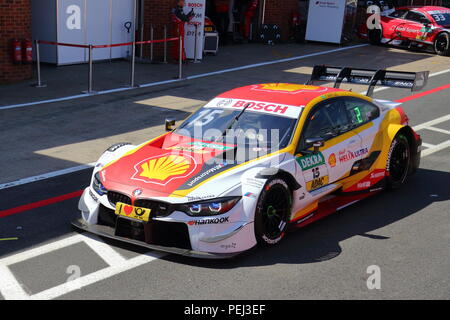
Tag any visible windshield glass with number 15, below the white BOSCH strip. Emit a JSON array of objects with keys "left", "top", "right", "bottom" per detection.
[{"left": 175, "top": 107, "right": 300, "bottom": 151}]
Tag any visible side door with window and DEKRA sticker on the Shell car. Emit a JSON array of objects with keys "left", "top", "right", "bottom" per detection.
[{"left": 296, "top": 97, "right": 362, "bottom": 194}]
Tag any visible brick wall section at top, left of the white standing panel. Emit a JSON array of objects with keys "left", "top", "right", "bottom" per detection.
[{"left": 264, "top": 0, "right": 298, "bottom": 41}]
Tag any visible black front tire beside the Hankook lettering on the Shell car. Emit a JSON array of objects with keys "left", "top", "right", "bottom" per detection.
[{"left": 255, "top": 178, "right": 292, "bottom": 246}]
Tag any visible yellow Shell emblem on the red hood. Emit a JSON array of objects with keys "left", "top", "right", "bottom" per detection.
[{"left": 139, "top": 155, "right": 190, "bottom": 181}]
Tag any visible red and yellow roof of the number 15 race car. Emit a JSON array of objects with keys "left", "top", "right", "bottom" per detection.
[{"left": 217, "top": 83, "right": 346, "bottom": 106}]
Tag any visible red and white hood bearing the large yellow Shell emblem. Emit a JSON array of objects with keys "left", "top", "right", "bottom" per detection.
[{"left": 100, "top": 133, "right": 235, "bottom": 198}]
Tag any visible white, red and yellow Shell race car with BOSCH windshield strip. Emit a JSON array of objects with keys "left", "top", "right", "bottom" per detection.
[{"left": 73, "top": 66, "right": 428, "bottom": 258}]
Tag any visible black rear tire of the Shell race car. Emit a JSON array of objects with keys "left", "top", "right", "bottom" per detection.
[{"left": 386, "top": 133, "right": 411, "bottom": 190}]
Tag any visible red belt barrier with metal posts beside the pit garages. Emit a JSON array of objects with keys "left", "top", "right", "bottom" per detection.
[{"left": 35, "top": 37, "right": 183, "bottom": 94}]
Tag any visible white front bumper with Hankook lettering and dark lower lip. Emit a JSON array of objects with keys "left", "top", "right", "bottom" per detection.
[{"left": 73, "top": 187, "right": 256, "bottom": 258}]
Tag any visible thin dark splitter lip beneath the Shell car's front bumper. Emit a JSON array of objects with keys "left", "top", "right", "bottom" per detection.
[{"left": 72, "top": 218, "right": 241, "bottom": 259}]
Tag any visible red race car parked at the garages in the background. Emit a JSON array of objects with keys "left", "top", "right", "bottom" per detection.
[{"left": 359, "top": 6, "right": 450, "bottom": 56}]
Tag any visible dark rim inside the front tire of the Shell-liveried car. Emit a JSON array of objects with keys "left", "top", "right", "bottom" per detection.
[{"left": 262, "top": 186, "right": 289, "bottom": 239}]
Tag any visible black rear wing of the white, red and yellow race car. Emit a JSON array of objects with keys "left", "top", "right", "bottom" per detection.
[{"left": 307, "top": 65, "right": 429, "bottom": 97}]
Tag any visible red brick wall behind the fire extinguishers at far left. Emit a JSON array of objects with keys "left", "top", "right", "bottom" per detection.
[{"left": 0, "top": 0, "right": 32, "bottom": 83}]
